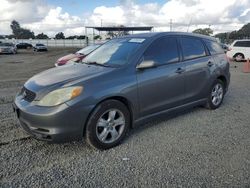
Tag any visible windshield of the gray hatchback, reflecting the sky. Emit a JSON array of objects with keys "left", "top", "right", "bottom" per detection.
[{"left": 83, "top": 38, "right": 145, "bottom": 66}]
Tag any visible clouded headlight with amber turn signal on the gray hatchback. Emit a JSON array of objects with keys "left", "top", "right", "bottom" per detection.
[{"left": 37, "top": 86, "right": 83, "bottom": 106}]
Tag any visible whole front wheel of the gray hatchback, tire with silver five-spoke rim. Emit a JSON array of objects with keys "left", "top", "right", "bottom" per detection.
[{"left": 85, "top": 100, "right": 130, "bottom": 150}]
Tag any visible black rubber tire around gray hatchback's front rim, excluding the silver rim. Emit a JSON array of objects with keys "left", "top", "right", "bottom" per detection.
[{"left": 85, "top": 100, "right": 130, "bottom": 150}]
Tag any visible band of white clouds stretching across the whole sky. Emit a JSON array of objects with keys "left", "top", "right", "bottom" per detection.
[{"left": 0, "top": 0, "right": 250, "bottom": 36}]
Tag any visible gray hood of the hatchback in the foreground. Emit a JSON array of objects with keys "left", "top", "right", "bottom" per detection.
[{"left": 24, "top": 63, "right": 113, "bottom": 92}]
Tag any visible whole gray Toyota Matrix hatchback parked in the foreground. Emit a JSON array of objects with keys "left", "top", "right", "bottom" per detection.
[{"left": 13, "top": 32, "right": 230, "bottom": 149}]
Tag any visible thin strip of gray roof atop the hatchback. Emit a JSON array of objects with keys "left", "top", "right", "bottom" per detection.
[{"left": 122, "top": 32, "right": 217, "bottom": 41}]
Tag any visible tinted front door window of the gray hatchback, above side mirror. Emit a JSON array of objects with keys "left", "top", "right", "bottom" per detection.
[{"left": 144, "top": 37, "right": 179, "bottom": 64}]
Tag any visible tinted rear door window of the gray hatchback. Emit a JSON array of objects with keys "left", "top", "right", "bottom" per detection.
[{"left": 181, "top": 37, "right": 206, "bottom": 60}]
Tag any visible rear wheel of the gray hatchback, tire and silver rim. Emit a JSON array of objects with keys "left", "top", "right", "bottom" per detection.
[{"left": 206, "top": 79, "right": 225, "bottom": 110}]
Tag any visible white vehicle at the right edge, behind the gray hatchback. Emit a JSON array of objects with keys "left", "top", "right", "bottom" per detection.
[{"left": 227, "top": 40, "right": 250, "bottom": 62}]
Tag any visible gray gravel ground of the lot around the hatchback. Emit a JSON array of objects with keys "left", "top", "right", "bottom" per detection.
[{"left": 0, "top": 49, "right": 250, "bottom": 187}]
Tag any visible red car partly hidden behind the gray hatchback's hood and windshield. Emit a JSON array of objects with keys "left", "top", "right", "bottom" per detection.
[{"left": 55, "top": 44, "right": 100, "bottom": 67}]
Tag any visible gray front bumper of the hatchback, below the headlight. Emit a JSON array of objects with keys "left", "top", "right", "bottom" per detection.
[{"left": 13, "top": 96, "right": 93, "bottom": 142}]
